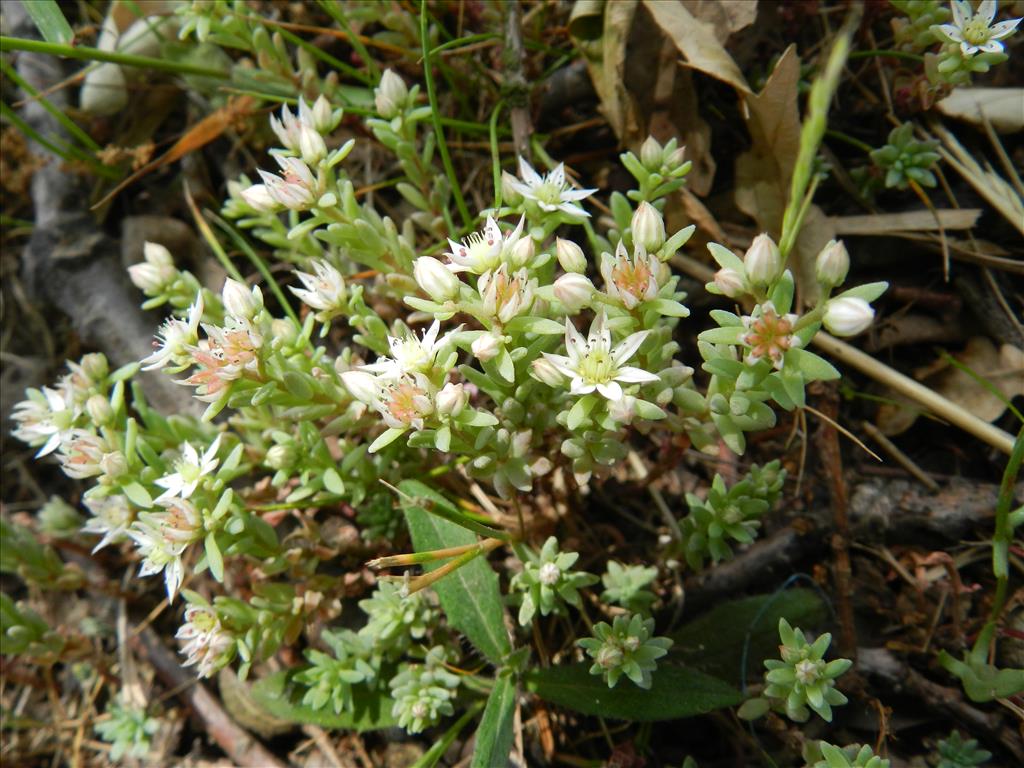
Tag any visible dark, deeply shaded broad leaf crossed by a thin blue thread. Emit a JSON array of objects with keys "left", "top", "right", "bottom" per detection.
[{"left": 655, "top": 589, "right": 825, "bottom": 684}]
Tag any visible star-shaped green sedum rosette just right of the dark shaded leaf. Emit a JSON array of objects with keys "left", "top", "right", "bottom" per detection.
[{"left": 740, "top": 618, "right": 853, "bottom": 723}]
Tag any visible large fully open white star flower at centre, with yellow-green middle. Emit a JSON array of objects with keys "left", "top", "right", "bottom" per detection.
[{"left": 544, "top": 312, "right": 658, "bottom": 400}]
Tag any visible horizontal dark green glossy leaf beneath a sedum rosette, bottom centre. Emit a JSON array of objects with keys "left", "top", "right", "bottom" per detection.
[{"left": 524, "top": 663, "right": 743, "bottom": 722}]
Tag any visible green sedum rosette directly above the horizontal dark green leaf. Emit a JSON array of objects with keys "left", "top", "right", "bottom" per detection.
[{"left": 578, "top": 613, "right": 672, "bottom": 688}]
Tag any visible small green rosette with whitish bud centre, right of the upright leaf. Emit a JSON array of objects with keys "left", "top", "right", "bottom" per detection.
[{"left": 511, "top": 537, "right": 597, "bottom": 627}]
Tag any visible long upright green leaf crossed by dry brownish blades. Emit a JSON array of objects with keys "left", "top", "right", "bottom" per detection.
[{"left": 398, "top": 480, "right": 512, "bottom": 665}]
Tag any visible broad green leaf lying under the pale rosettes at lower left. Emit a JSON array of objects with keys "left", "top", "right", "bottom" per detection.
[{"left": 250, "top": 671, "right": 398, "bottom": 733}]
